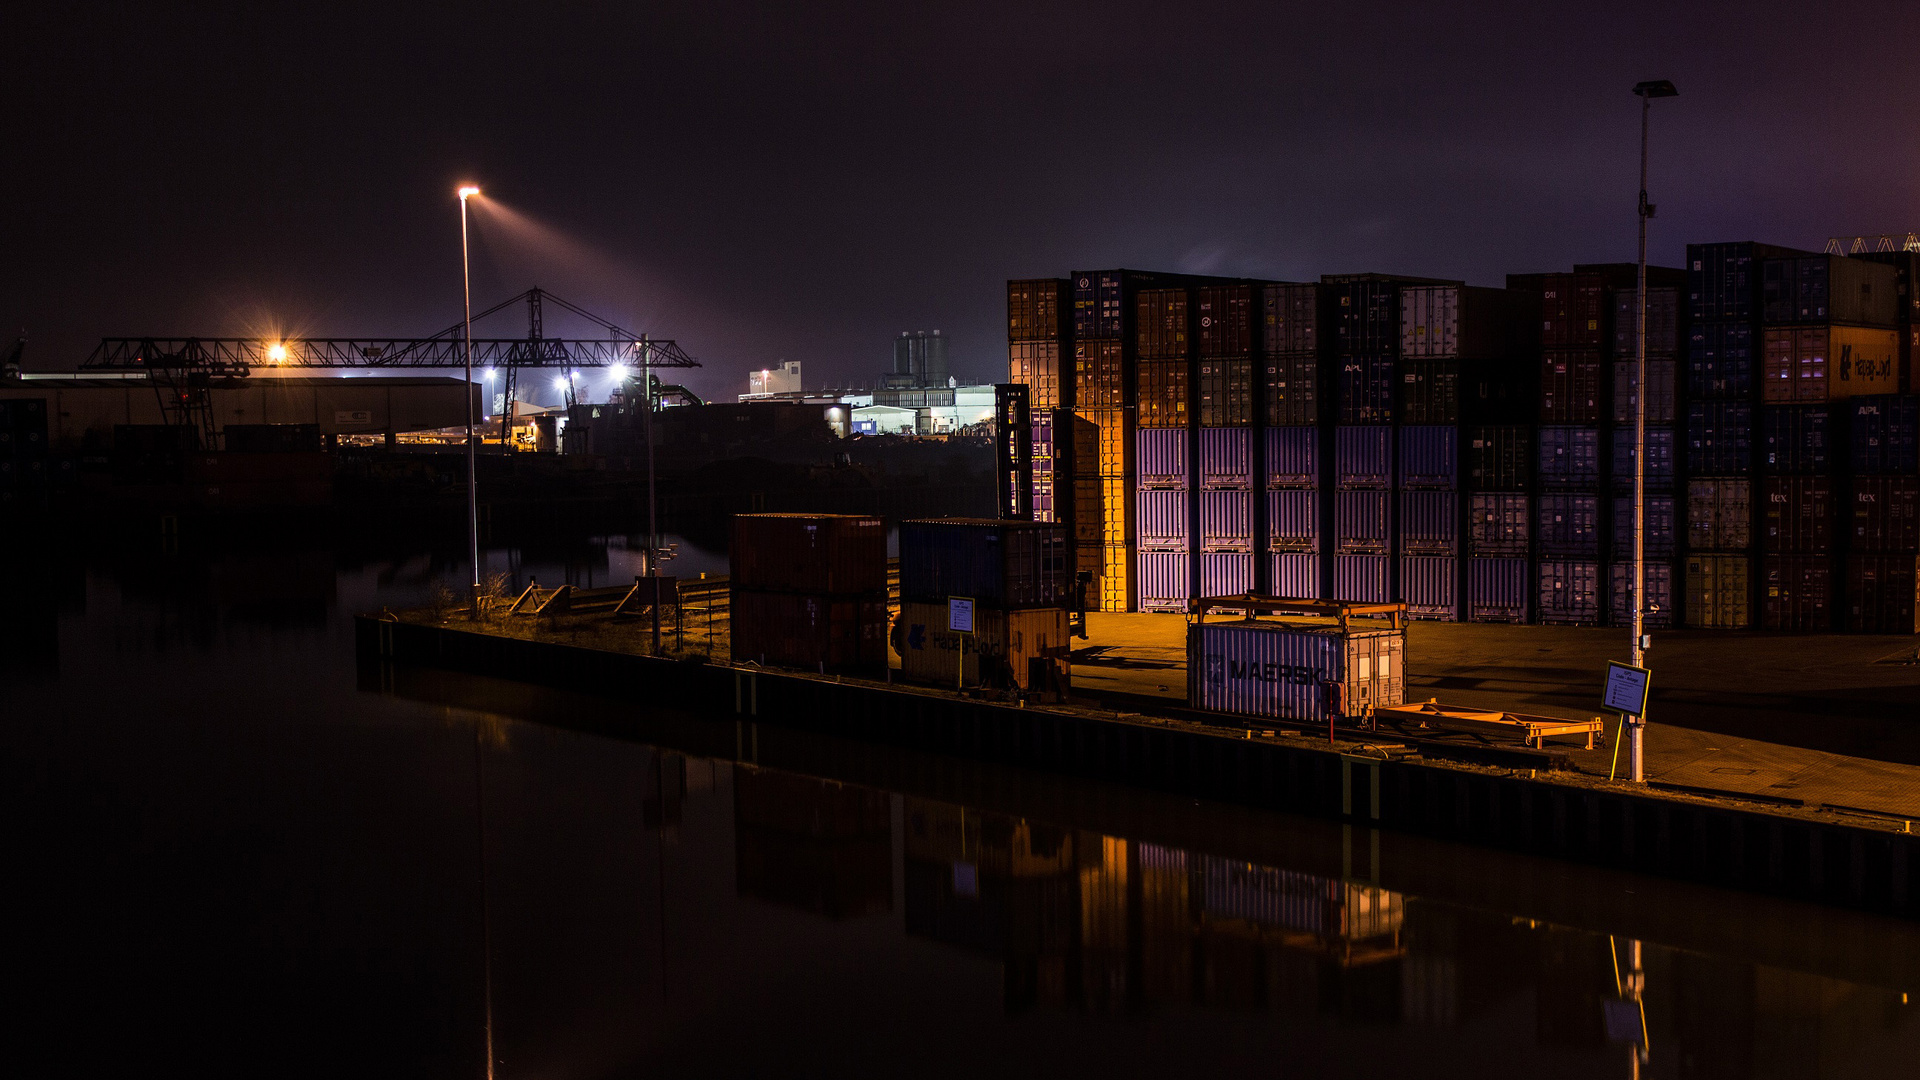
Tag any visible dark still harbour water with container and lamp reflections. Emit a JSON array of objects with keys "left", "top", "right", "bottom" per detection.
[{"left": 0, "top": 542, "right": 1920, "bottom": 1076}]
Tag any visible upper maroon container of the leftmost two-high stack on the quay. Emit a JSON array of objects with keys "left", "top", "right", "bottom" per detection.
[{"left": 732, "top": 513, "right": 887, "bottom": 600}]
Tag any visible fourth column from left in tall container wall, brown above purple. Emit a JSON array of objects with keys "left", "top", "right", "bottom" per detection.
[{"left": 1194, "top": 282, "right": 1261, "bottom": 596}]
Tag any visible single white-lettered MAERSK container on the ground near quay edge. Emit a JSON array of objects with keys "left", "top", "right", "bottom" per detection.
[{"left": 1187, "top": 619, "right": 1407, "bottom": 723}]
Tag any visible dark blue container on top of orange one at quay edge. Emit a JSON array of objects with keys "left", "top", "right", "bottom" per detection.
[{"left": 902, "top": 517, "right": 1073, "bottom": 607}]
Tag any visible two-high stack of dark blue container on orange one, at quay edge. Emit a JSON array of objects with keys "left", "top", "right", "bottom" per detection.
[{"left": 895, "top": 517, "right": 1073, "bottom": 688}]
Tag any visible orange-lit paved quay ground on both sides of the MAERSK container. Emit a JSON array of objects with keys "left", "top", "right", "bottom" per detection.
[{"left": 1073, "top": 613, "right": 1920, "bottom": 822}]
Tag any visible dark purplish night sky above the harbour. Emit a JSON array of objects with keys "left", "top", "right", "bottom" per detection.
[{"left": 0, "top": 0, "right": 1920, "bottom": 396}]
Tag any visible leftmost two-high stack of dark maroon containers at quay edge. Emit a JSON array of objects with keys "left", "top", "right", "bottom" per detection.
[{"left": 730, "top": 513, "right": 887, "bottom": 673}]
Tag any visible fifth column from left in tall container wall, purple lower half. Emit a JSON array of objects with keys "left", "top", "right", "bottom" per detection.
[{"left": 1260, "top": 282, "right": 1323, "bottom": 598}]
